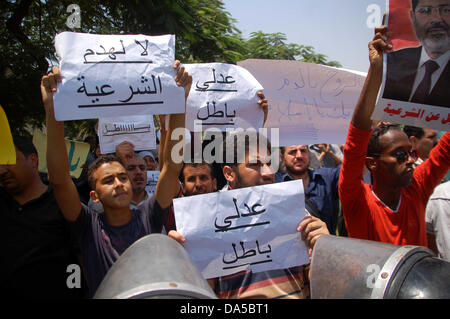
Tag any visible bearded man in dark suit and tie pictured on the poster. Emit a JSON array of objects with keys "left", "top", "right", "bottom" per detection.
[{"left": 383, "top": 0, "right": 450, "bottom": 107}]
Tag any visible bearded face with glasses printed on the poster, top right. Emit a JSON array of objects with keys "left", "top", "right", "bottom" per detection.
[{"left": 410, "top": 0, "right": 450, "bottom": 58}]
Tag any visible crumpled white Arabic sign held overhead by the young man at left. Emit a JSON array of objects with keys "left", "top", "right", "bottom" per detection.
[{"left": 55, "top": 32, "right": 184, "bottom": 121}]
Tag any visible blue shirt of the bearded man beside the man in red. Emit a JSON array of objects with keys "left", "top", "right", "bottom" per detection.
[{"left": 275, "top": 165, "right": 341, "bottom": 235}]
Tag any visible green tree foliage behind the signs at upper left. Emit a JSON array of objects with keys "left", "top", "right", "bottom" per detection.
[{"left": 0, "top": 0, "right": 338, "bottom": 137}]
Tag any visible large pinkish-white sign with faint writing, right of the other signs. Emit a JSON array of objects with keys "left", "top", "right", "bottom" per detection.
[{"left": 238, "top": 59, "right": 365, "bottom": 146}]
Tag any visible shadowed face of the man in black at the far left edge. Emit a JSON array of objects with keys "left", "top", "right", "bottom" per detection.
[{"left": 0, "top": 148, "right": 38, "bottom": 196}]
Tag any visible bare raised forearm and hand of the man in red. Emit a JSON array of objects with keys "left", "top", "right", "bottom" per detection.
[{"left": 352, "top": 26, "right": 392, "bottom": 130}]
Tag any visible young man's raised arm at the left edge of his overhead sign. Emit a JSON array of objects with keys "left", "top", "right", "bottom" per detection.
[{"left": 41, "top": 67, "right": 81, "bottom": 221}]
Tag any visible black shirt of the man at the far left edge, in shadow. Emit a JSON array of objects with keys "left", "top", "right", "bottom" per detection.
[{"left": 0, "top": 187, "right": 84, "bottom": 299}]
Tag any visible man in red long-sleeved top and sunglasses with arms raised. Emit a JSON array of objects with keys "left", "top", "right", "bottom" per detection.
[{"left": 339, "top": 26, "right": 450, "bottom": 246}]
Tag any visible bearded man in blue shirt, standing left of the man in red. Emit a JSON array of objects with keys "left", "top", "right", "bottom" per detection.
[{"left": 275, "top": 145, "right": 341, "bottom": 235}]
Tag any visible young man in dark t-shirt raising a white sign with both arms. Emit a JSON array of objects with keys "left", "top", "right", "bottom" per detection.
[{"left": 41, "top": 61, "right": 192, "bottom": 295}]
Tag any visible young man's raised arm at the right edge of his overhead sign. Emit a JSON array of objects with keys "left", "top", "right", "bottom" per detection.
[{"left": 155, "top": 60, "right": 192, "bottom": 209}]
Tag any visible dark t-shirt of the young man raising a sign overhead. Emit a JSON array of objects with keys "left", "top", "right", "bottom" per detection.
[{"left": 72, "top": 196, "right": 170, "bottom": 297}]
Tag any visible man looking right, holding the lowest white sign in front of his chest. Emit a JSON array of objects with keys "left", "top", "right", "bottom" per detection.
[{"left": 169, "top": 131, "right": 329, "bottom": 298}]
